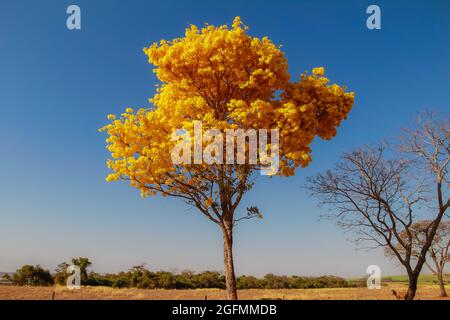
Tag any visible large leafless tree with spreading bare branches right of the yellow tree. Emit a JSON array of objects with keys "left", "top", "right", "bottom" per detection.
[{"left": 307, "top": 113, "right": 450, "bottom": 300}]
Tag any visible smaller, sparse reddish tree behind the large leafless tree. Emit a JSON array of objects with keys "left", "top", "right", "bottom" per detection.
[{"left": 385, "top": 220, "right": 450, "bottom": 297}]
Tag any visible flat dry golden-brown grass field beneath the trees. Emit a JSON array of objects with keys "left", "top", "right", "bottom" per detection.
[{"left": 0, "top": 283, "right": 450, "bottom": 300}]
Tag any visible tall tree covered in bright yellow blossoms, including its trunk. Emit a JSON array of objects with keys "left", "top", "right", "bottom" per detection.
[{"left": 100, "top": 17, "right": 354, "bottom": 299}]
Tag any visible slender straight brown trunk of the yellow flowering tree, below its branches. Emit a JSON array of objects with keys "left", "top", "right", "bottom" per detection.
[{"left": 222, "top": 222, "right": 238, "bottom": 300}]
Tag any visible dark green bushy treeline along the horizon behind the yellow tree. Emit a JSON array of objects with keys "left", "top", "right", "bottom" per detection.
[{"left": 1, "top": 258, "right": 357, "bottom": 289}]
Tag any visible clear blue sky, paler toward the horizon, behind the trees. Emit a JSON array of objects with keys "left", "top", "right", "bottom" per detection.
[{"left": 0, "top": 0, "right": 450, "bottom": 276}]
